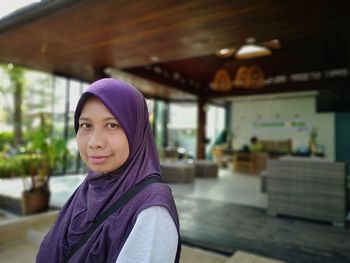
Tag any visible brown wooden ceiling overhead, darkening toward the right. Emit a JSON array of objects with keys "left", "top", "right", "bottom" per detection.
[{"left": 0, "top": 0, "right": 350, "bottom": 99}]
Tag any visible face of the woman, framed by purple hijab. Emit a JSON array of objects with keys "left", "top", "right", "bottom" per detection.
[{"left": 76, "top": 97, "right": 129, "bottom": 173}]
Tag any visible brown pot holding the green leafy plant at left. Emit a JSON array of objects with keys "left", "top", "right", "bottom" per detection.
[{"left": 22, "top": 190, "right": 50, "bottom": 215}]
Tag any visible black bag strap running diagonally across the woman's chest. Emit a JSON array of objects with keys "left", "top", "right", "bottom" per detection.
[{"left": 64, "top": 177, "right": 161, "bottom": 262}]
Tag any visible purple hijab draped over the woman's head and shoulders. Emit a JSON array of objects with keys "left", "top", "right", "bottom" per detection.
[{"left": 37, "top": 78, "right": 179, "bottom": 263}]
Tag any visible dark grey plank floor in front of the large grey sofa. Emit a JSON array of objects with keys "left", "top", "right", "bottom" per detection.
[{"left": 175, "top": 196, "right": 350, "bottom": 263}]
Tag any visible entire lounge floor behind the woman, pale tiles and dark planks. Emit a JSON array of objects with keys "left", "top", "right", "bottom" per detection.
[{"left": 0, "top": 169, "right": 350, "bottom": 263}]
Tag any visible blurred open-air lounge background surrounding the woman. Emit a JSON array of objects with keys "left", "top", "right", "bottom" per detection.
[{"left": 0, "top": 0, "right": 350, "bottom": 263}]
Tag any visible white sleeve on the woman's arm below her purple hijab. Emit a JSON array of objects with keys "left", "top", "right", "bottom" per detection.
[{"left": 116, "top": 206, "right": 179, "bottom": 263}]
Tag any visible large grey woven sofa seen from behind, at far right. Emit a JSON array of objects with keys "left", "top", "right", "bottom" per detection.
[{"left": 266, "top": 157, "right": 347, "bottom": 226}]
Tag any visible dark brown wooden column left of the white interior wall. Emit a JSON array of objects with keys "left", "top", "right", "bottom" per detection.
[{"left": 197, "top": 97, "right": 206, "bottom": 159}]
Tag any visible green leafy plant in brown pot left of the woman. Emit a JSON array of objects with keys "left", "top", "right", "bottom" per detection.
[{"left": 22, "top": 114, "right": 67, "bottom": 214}]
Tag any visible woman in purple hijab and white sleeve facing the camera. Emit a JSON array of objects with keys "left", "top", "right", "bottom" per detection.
[{"left": 37, "top": 79, "right": 180, "bottom": 263}]
